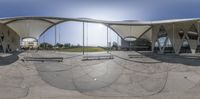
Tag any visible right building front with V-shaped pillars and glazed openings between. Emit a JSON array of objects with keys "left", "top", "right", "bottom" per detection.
[{"left": 152, "top": 21, "right": 200, "bottom": 54}]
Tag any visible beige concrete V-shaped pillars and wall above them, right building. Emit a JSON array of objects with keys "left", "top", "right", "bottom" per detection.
[{"left": 152, "top": 21, "right": 199, "bottom": 54}]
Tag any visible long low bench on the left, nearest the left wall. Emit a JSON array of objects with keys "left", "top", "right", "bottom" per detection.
[{"left": 22, "top": 57, "right": 63, "bottom": 62}]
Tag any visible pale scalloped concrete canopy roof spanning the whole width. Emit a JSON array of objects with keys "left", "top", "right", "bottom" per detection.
[{"left": 0, "top": 17, "right": 200, "bottom": 39}]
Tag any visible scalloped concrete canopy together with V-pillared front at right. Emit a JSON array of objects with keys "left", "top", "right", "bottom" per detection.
[{"left": 0, "top": 17, "right": 200, "bottom": 53}]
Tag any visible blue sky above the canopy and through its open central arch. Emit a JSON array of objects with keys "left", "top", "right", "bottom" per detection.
[{"left": 0, "top": 0, "right": 200, "bottom": 45}]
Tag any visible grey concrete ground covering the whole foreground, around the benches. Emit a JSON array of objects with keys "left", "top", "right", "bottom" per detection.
[{"left": 0, "top": 51, "right": 200, "bottom": 99}]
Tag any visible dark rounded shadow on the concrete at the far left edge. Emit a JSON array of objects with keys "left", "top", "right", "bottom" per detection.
[{"left": 0, "top": 52, "right": 20, "bottom": 66}]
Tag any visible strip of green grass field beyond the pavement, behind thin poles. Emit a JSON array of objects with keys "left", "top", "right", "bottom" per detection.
[{"left": 59, "top": 47, "right": 105, "bottom": 52}]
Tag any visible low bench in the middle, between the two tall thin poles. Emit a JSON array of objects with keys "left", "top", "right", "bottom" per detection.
[{"left": 82, "top": 55, "right": 114, "bottom": 61}]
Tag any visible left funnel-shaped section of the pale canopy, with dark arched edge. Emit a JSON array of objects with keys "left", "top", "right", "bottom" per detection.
[{"left": 0, "top": 17, "right": 66, "bottom": 39}]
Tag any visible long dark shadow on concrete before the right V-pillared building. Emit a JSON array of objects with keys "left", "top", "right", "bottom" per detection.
[{"left": 138, "top": 52, "right": 200, "bottom": 66}]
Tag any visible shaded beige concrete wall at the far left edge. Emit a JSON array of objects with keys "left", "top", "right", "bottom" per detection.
[{"left": 0, "top": 24, "right": 20, "bottom": 52}]
